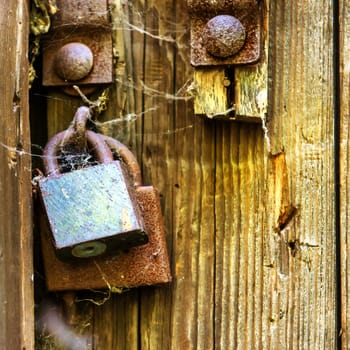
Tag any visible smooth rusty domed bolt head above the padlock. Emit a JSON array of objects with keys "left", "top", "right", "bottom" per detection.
[{"left": 54, "top": 43, "right": 94, "bottom": 81}]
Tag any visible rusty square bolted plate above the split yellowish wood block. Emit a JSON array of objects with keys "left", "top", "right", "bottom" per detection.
[{"left": 187, "top": 0, "right": 261, "bottom": 66}]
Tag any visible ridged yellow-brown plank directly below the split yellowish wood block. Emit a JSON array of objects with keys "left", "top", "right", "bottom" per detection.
[{"left": 215, "top": 124, "right": 266, "bottom": 349}]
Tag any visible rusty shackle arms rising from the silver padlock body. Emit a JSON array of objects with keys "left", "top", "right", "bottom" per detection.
[{"left": 43, "top": 128, "right": 113, "bottom": 176}]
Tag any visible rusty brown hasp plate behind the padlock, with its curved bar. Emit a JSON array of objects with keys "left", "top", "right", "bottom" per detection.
[{"left": 39, "top": 106, "right": 171, "bottom": 291}]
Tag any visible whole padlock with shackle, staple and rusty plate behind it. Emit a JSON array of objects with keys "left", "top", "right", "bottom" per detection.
[{"left": 38, "top": 107, "right": 171, "bottom": 291}]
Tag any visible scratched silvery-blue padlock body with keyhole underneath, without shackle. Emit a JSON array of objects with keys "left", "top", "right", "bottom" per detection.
[{"left": 39, "top": 161, "right": 148, "bottom": 260}]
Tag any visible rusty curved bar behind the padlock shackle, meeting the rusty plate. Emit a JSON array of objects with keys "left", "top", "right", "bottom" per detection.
[{"left": 100, "top": 135, "right": 142, "bottom": 187}]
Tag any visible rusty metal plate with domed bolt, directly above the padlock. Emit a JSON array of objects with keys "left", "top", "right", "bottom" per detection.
[{"left": 43, "top": 0, "right": 113, "bottom": 90}]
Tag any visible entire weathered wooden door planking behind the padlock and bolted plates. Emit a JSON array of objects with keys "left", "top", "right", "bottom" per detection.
[{"left": 0, "top": 0, "right": 350, "bottom": 350}]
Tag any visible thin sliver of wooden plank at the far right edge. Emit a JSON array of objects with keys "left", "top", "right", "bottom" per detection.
[{"left": 339, "top": 0, "right": 350, "bottom": 349}]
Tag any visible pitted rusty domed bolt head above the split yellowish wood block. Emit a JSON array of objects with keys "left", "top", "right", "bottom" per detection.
[{"left": 202, "top": 15, "right": 246, "bottom": 58}]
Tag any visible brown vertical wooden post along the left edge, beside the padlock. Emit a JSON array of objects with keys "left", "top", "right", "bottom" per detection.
[{"left": 0, "top": 1, "right": 34, "bottom": 350}]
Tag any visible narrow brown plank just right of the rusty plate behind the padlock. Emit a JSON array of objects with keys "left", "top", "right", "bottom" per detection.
[{"left": 170, "top": 1, "right": 216, "bottom": 349}]
